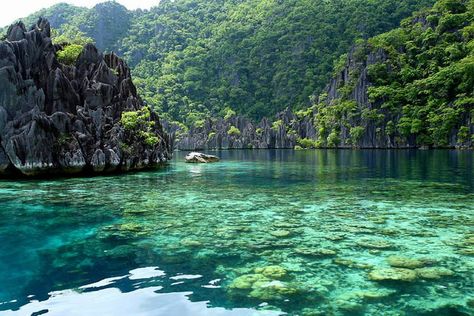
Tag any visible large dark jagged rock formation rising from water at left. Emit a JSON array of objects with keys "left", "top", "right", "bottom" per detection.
[{"left": 0, "top": 19, "right": 171, "bottom": 176}]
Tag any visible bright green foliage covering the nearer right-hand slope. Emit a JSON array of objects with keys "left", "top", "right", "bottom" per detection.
[{"left": 316, "top": 0, "right": 474, "bottom": 146}]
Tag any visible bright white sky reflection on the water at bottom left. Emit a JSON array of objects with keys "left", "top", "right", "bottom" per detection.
[{"left": 2, "top": 267, "right": 281, "bottom": 316}]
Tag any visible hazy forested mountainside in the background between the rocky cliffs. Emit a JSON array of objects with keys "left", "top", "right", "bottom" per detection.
[{"left": 5, "top": 0, "right": 434, "bottom": 126}]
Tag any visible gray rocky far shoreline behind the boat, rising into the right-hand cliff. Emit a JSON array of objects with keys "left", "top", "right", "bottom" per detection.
[{"left": 170, "top": 41, "right": 474, "bottom": 150}]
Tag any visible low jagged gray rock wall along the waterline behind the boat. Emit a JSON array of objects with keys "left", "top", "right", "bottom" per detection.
[{"left": 172, "top": 109, "right": 316, "bottom": 150}]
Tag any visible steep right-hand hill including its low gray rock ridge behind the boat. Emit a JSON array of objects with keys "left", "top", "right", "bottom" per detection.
[{"left": 176, "top": 0, "right": 474, "bottom": 149}]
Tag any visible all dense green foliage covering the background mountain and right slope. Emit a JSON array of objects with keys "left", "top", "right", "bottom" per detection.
[{"left": 9, "top": 0, "right": 468, "bottom": 148}]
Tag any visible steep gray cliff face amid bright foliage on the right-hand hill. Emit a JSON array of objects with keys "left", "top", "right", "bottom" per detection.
[{"left": 315, "top": 42, "right": 474, "bottom": 148}]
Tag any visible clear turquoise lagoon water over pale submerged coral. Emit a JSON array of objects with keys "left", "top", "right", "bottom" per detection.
[{"left": 0, "top": 150, "right": 474, "bottom": 316}]
